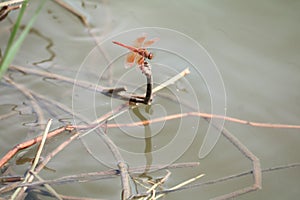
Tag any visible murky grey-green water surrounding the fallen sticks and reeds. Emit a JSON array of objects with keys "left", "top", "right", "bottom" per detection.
[{"left": 0, "top": 0, "right": 300, "bottom": 199}]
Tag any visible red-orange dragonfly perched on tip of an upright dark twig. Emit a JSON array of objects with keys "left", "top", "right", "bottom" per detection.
[{"left": 113, "top": 35, "right": 159, "bottom": 67}]
